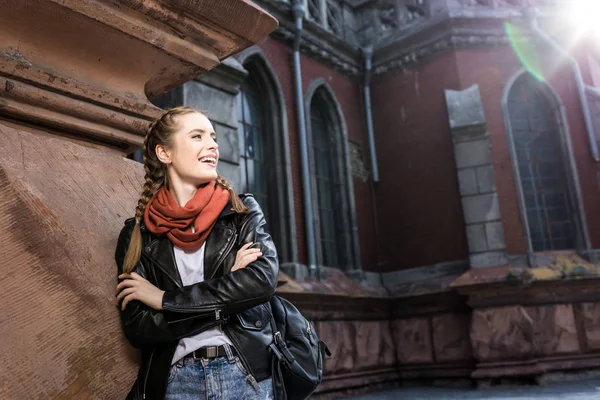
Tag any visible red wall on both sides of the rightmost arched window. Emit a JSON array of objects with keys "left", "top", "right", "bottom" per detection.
[{"left": 456, "top": 47, "right": 600, "bottom": 254}]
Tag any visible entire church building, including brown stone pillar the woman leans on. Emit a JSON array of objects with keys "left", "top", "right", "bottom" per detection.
[{"left": 0, "top": 0, "right": 600, "bottom": 399}]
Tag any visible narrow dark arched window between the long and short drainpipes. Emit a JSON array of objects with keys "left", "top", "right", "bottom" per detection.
[{"left": 306, "top": 85, "right": 360, "bottom": 271}]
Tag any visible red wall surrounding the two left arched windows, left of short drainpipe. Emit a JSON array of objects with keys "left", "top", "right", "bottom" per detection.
[{"left": 260, "top": 38, "right": 377, "bottom": 271}]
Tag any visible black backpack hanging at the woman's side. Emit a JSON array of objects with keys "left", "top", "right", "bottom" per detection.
[{"left": 269, "top": 296, "right": 331, "bottom": 400}]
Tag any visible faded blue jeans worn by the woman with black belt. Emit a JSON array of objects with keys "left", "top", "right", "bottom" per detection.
[{"left": 165, "top": 342, "right": 273, "bottom": 400}]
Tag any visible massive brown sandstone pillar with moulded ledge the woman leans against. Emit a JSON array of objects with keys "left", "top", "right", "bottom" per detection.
[{"left": 0, "top": 0, "right": 277, "bottom": 399}]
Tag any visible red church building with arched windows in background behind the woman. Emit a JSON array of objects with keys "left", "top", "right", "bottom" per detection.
[{"left": 149, "top": 0, "right": 600, "bottom": 394}]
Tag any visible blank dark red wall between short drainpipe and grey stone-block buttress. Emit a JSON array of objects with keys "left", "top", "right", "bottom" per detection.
[{"left": 372, "top": 53, "right": 468, "bottom": 271}]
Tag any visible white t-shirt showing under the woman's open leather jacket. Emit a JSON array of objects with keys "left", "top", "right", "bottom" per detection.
[{"left": 171, "top": 244, "right": 232, "bottom": 365}]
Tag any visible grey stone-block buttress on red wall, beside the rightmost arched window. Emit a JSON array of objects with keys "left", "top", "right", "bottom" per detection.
[{"left": 445, "top": 85, "right": 508, "bottom": 268}]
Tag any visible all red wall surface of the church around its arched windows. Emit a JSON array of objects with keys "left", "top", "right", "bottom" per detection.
[{"left": 261, "top": 38, "right": 600, "bottom": 271}]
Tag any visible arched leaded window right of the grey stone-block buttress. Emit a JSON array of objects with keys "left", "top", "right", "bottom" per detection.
[{"left": 507, "top": 73, "right": 577, "bottom": 251}]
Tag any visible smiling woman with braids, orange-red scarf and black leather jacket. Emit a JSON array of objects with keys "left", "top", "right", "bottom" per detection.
[{"left": 115, "top": 107, "right": 279, "bottom": 400}]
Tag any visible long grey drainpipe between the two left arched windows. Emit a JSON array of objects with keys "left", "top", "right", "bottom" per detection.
[{"left": 292, "top": 0, "right": 320, "bottom": 279}]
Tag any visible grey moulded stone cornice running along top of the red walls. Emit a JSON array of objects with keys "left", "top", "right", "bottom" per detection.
[{"left": 261, "top": 0, "right": 551, "bottom": 77}]
